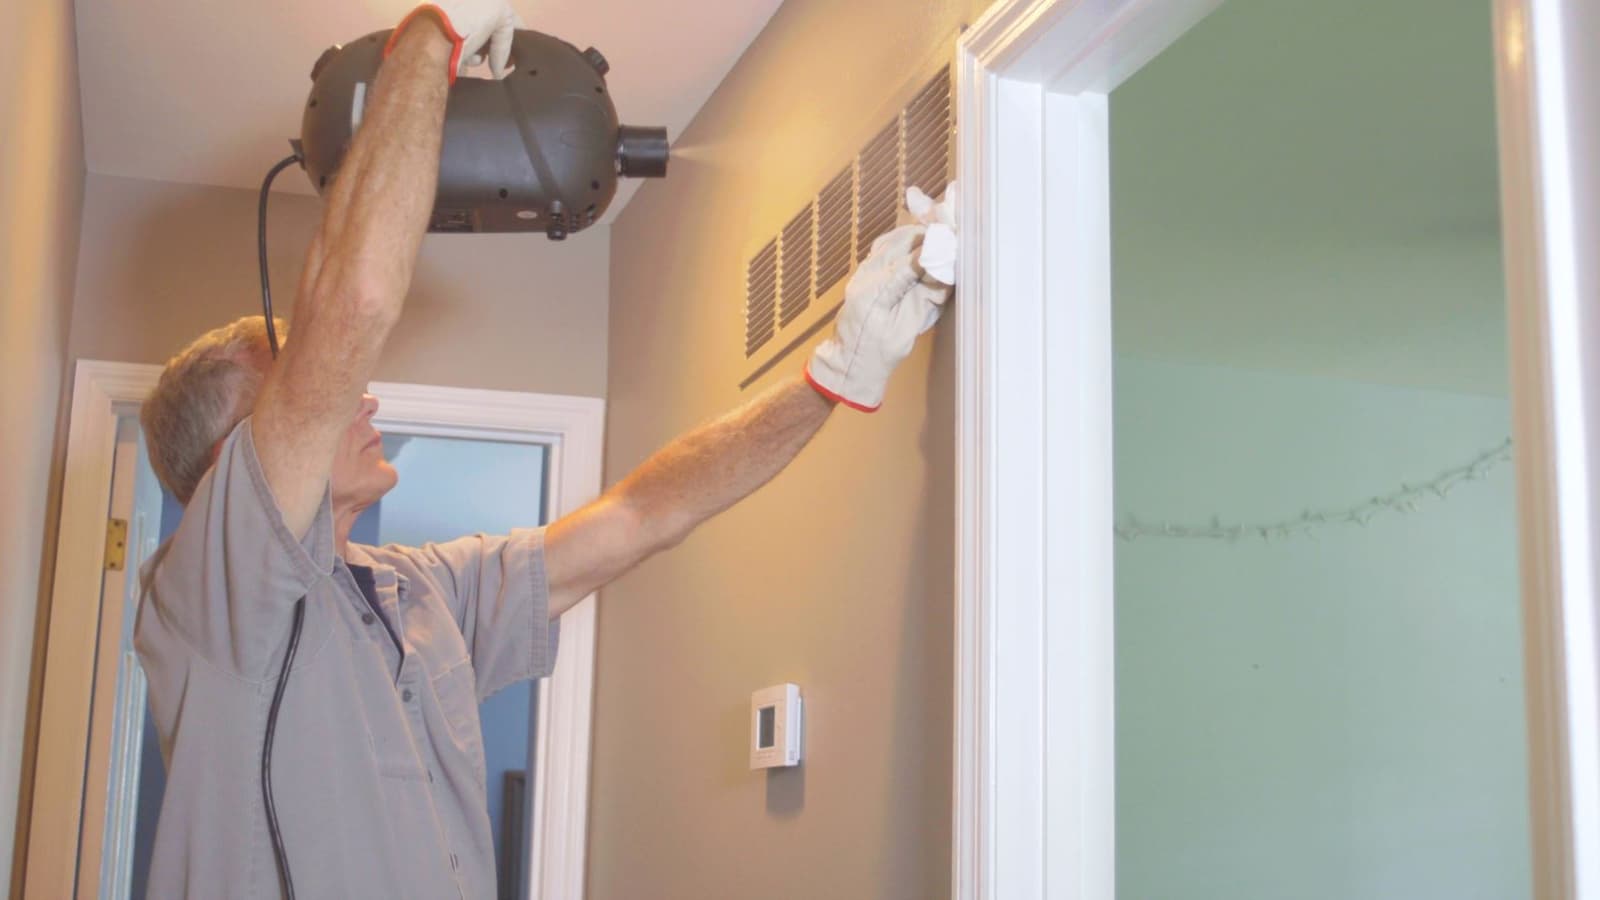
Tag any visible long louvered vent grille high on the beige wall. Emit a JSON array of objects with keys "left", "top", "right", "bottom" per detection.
[{"left": 741, "top": 67, "right": 955, "bottom": 374}]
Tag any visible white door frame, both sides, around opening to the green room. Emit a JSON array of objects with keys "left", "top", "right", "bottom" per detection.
[{"left": 952, "top": 0, "right": 1600, "bottom": 900}]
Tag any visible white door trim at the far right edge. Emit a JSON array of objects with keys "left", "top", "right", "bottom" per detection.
[{"left": 1494, "top": 0, "right": 1600, "bottom": 900}]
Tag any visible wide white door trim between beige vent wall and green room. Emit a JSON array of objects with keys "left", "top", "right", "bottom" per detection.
[{"left": 952, "top": 0, "right": 1219, "bottom": 900}]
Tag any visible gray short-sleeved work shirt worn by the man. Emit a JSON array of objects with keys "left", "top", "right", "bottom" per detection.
[{"left": 134, "top": 418, "right": 557, "bottom": 900}]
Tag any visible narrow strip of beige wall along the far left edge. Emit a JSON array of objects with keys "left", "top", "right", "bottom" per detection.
[{"left": 0, "top": 0, "right": 83, "bottom": 886}]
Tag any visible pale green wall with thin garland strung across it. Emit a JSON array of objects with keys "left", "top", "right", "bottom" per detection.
[{"left": 1115, "top": 357, "right": 1530, "bottom": 900}]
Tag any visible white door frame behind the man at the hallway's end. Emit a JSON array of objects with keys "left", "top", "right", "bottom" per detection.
[{"left": 22, "top": 360, "right": 605, "bottom": 900}]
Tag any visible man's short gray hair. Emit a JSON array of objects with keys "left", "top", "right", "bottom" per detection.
[{"left": 139, "top": 315, "right": 286, "bottom": 506}]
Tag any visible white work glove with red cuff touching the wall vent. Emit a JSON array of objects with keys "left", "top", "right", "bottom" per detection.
[{"left": 805, "top": 186, "right": 955, "bottom": 413}]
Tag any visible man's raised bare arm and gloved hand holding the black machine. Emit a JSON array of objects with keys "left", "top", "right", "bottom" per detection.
[{"left": 251, "top": 0, "right": 515, "bottom": 535}]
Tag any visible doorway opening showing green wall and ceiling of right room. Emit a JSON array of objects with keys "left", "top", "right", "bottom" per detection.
[{"left": 1109, "top": 0, "right": 1533, "bottom": 900}]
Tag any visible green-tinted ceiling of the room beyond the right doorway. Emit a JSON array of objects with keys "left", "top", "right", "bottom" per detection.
[{"left": 1110, "top": 0, "right": 1507, "bottom": 394}]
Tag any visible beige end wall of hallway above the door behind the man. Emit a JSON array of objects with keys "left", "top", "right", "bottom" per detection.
[{"left": 70, "top": 167, "right": 608, "bottom": 397}]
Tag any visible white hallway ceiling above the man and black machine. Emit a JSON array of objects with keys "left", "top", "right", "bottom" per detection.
[{"left": 77, "top": 0, "right": 781, "bottom": 221}]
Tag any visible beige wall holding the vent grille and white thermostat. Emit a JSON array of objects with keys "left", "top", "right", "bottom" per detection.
[{"left": 589, "top": 0, "right": 986, "bottom": 900}]
